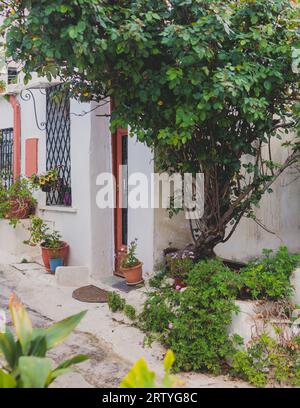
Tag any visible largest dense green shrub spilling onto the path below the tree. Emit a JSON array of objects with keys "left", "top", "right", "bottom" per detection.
[{"left": 139, "top": 260, "right": 239, "bottom": 373}]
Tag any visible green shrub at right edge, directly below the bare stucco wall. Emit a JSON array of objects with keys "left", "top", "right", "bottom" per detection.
[{"left": 240, "top": 247, "right": 300, "bottom": 300}]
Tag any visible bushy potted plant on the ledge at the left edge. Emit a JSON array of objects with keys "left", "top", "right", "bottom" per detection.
[{"left": 0, "top": 179, "right": 36, "bottom": 220}]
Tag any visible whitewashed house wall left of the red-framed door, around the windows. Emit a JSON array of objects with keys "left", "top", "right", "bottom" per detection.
[{"left": 0, "top": 90, "right": 114, "bottom": 279}]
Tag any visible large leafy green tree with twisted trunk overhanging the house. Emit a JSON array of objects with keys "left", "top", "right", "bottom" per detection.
[{"left": 0, "top": 0, "right": 300, "bottom": 252}]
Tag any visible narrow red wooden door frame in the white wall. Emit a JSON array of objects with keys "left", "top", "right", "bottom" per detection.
[{"left": 112, "top": 129, "right": 128, "bottom": 277}]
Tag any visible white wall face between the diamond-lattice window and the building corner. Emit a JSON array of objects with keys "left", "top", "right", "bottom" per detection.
[{"left": 39, "top": 100, "right": 91, "bottom": 268}]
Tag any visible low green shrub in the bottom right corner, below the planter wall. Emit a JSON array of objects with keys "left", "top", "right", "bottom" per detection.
[{"left": 232, "top": 333, "right": 300, "bottom": 387}]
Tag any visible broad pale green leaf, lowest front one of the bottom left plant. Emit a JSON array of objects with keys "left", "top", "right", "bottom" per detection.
[{"left": 18, "top": 357, "right": 51, "bottom": 388}]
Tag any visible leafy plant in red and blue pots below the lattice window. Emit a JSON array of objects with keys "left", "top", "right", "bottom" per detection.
[{"left": 25, "top": 217, "right": 69, "bottom": 272}]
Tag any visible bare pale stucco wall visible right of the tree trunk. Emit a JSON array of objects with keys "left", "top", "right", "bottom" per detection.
[{"left": 217, "top": 140, "right": 300, "bottom": 260}]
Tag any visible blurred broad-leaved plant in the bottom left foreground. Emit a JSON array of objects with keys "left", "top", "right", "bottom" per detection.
[{"left": 0, "top": 296, "right": 88, "bottom": 388}]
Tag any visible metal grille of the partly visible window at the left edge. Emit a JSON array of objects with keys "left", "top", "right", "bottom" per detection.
[{"left": 0, "top": 128, "right": 14, "bottom": 188}]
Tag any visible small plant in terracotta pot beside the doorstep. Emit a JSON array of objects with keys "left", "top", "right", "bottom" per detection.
[{"left": 121, "top": 239, "right": 143, "bottom": 285}]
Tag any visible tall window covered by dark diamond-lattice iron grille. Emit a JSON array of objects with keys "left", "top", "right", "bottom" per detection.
[{"left": 46, "top": 85, "right": 72, "bottom": 207}]
